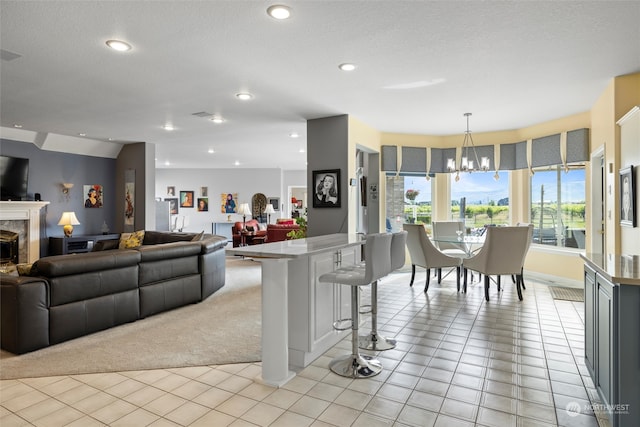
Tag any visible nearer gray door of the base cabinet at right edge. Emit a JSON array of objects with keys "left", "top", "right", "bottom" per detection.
[{"left": 595, "top": 275, "right": 615, "bottom": 404}]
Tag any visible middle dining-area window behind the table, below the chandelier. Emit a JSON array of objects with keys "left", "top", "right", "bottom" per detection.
[{"left": 451, "top": 172, "right": 509, "bottom": 228}]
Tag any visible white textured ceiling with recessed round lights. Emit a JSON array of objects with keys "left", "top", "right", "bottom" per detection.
[{"left": 0, "top": 0, "right": 640, "bottom": 169}]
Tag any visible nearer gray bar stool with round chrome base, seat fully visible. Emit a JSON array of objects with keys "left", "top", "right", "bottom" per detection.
[{"left": 318, "top": 233, "right": 391, "bottom": 378}]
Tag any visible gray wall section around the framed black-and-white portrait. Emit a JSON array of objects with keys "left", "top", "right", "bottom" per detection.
[{"left": 307, "top": 115, "right": 355, "bottom": 237}]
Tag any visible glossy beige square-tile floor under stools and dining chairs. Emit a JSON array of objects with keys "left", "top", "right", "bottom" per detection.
[{"left": 0, "top": 270, "right": 609, "bottom": 427}]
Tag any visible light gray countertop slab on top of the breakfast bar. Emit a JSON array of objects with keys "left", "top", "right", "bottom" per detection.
[{"left": 226, "top": 233, "right": 364, "bottom": 258}]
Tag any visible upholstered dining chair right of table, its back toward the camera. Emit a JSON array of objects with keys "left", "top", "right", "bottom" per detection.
[{"left": 462, "top": 226, "right": 529, "bottom": 301}]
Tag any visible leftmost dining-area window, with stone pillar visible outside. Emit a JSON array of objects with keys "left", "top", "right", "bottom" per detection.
[{"left": 386, "top": 175, "right": 435, "bottom": 232}]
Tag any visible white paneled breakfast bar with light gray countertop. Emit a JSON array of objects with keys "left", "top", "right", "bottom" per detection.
[{"left": 226, "top": 234, "right": 364, "bottom": 387}]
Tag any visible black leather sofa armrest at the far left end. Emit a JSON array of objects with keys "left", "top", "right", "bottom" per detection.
[{"left": 0, "top": 274, "right": 49, "bottom": 354}]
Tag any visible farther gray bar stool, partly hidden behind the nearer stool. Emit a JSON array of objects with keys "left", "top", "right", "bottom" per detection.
[{"left": 358, "top": 231, "right": 408, "bottom": 351}]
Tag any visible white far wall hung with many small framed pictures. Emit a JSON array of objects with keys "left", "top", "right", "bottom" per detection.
[{"left": 155, "top": 169, "right": 306, "bottom": 233}]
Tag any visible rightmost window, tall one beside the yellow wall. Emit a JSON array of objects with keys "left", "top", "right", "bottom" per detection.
[{"left": 531, "top": 165, "right": 586, "bottom": 249}]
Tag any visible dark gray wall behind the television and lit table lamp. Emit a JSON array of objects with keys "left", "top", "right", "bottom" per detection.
[{"left": 0, "top": 139, "right": 117, "bottom": 256}]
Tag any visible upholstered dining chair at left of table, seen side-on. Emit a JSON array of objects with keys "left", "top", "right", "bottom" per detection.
[{"left": 402, "top": 224, "right": 466, "bottom": 292}]
